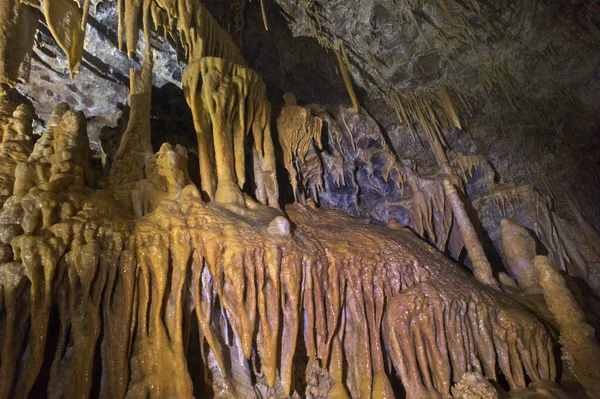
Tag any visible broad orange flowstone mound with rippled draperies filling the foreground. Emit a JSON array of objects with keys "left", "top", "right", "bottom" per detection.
[{"left": 0, "top": 100, "right": 554, "bottom": 398}]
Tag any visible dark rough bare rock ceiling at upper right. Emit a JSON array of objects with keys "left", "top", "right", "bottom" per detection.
[{"left": 277, "top": 0, "right": 600, "bottom": 231}]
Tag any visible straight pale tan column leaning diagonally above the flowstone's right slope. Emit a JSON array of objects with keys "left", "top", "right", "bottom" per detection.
[{"left": 444, "top": 179, "right": 498, "bottom": 288}]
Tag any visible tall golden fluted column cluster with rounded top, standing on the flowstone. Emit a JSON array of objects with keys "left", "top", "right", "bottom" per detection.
[{"left": 184, "top": 57, "right": 279, "bottom": 208}]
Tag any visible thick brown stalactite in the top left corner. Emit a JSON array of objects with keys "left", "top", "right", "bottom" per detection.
[{"left": 0, "top": 0, "right": 38, "bottom": 86}]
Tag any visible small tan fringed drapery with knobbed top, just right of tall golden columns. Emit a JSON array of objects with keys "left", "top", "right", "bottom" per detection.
[{"left": 277, "top": 93, "right": 323, "bottom": 203}]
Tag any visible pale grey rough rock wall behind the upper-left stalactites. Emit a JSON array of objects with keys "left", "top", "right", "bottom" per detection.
[{"left": 12, "top": 1, "right": 182, "bottom": 157}]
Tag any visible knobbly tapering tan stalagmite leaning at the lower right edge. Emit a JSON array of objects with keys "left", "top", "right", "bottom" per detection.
[{"left": 535, "top": 256, "right": 600, "bottom": 398}]
